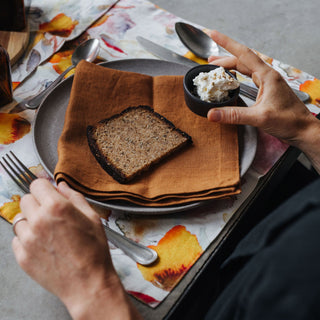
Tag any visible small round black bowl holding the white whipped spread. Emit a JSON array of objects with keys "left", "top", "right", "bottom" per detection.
[{"left": 183, "top": 64, "right": 240, "bottom": 117}]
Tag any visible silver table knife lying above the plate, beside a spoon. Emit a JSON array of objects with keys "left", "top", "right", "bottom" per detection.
[{"left": 136, "top": 36, "right": 310, "bottom": 102}]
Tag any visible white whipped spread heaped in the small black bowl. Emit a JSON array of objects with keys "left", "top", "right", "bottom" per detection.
[{"left": 193, "top": 67, "right": 240, "bottom": 102}]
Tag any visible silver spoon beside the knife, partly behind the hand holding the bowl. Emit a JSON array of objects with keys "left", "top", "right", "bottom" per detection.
[{"left": 175, "top": 22, "right": 310, "bottom": 102}]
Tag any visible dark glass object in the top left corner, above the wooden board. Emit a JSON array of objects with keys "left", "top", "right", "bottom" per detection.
[{"left": 0, "top": 0, "right": 26, "bottom": 31}]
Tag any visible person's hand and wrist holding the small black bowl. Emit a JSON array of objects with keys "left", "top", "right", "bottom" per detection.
[{"left": 208, "top": 31, "right": 320, "bottom": 173}]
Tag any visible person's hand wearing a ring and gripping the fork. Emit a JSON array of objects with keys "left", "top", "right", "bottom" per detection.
[{"left": 12, "top": 179, "right": 141, "bottom": 319}]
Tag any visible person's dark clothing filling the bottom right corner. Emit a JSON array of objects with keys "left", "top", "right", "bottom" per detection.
[{"left": 206, "top": 179, "right": 320, "bottom": 320}]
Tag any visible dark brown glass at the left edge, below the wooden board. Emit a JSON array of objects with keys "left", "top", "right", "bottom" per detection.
[{"left": 0, "top": 45, "right": 12, "bottom": 106}]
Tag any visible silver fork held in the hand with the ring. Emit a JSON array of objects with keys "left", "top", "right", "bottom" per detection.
[{"left": 0, "top": 151, "right": 158, "bottom": 265}]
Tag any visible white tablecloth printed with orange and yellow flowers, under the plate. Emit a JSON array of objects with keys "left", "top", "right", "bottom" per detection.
[{"left": 0, "top": 0, "right": 320, "bottom": 307}]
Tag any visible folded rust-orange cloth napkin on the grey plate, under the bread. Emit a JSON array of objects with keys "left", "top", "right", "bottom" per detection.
[{"left": 55, "top": 61, "right": 240, "bottom": 206}]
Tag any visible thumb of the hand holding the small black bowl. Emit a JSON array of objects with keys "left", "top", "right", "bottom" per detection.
[{"left": 207, "top": 107, "right": 256, "bottom": 126}]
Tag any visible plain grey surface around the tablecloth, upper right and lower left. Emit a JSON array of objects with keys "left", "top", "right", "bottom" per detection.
[{"left": 0, "top": 0, "right": 320, "bottom": 320}]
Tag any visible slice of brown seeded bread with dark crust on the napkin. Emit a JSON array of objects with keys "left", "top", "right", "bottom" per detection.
[{"left": 87, "top": 106, "right": 192, "bottom": 183}]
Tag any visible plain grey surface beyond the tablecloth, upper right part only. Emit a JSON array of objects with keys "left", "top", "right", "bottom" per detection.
[{"left": 153, "top": 0, "right": 320, "bottom": 78}]
